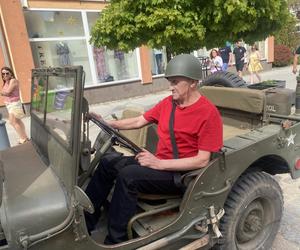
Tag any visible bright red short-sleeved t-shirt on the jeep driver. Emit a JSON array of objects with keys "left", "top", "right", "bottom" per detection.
[{"left": 144, "top": 96, "right": 223, "bottom": 159}]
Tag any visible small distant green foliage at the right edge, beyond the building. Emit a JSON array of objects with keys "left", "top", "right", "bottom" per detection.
[{"left": 275, "top": 16, "right": 300, "bottom": 51}]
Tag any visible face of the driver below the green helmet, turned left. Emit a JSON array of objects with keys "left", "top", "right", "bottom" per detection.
[{"left": 168, "top": 76, "right": 193, "bottom": 102}]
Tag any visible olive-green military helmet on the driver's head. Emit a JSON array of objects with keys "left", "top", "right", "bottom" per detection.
[{"left": 165, "top": 54, "right": 202, "bottom": 80}]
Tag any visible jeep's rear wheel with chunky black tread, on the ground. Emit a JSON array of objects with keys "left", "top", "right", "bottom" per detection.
[{"left": 214, "top": 172, "right": 283, "bottom": 250}]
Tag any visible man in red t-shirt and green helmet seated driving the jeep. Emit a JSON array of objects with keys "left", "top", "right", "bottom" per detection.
[{"left": 85, "top": 54, "right": 223, "bottom": 244}]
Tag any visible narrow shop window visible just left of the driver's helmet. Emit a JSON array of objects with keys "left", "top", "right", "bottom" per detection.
[{"left": 150, "top": 47, "right": 167, "bottom": 75}]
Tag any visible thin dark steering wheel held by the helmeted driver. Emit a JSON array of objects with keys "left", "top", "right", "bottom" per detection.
[{"left": 88, "top": 114, "right": 142, "bottom": 154}]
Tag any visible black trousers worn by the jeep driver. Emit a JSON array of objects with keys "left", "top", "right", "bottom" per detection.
[{"left": 85, "top": 153, "right": 182, "bottom": 244}]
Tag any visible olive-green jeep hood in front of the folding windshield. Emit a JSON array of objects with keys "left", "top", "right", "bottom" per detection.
[{"left": 0, "top": 142, "right": 69, "bottom": 249}]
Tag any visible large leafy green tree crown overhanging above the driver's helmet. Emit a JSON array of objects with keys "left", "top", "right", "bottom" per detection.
[{"left": 91, "top": 0, "right": 289, "bottom": 53}]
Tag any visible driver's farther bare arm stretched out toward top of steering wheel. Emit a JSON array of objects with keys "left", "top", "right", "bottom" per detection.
[{"left": 106, "top": 115, "right": 149, "bottom": 130}]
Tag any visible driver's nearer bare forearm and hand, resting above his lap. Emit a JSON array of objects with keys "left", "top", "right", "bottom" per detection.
[{"left": 136, "top": 150, "right": 211, "bottom": 171}]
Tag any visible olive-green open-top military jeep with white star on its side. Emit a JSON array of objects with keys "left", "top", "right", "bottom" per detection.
[{"left": 0, "top": 67, "right": 300, "bottom": 250}]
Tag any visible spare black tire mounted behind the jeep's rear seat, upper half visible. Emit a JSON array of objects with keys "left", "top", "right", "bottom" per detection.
[{"left": 201, "top": 71, "right": 247, "bottom": 88}]
